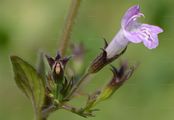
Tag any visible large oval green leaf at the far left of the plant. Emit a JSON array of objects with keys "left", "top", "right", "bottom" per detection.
[{"left": 11, "top": 56, "right": 45, "bottom": 114}]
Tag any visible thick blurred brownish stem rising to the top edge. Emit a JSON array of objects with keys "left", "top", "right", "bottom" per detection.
[{"left": 60, "top": 0, "right": 81, "bottom": 56}]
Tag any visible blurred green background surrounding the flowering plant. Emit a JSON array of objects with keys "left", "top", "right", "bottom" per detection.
[{"left": 0, "top": 0, "right": 174, "bottom": 120}]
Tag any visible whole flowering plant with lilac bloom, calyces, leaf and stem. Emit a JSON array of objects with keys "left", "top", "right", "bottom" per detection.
[{"left": 11, "top": 0, "right": 163, "bottom": 120}]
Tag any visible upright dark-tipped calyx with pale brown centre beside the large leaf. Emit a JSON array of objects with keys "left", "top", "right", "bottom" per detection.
[{"left": 46, "top": 53, "right": 73, "bottom": 102}]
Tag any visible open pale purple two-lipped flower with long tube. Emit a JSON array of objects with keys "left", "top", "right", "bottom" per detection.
[{"left": 105, "top": 5, "right": 163, "bottom": 58}]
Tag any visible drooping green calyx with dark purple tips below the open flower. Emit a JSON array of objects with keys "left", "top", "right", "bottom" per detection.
[{"left": 85, "top": 62, "right": 135, "bottom": 110}]
